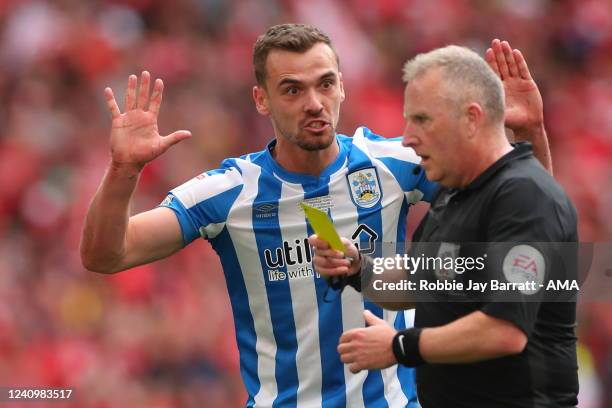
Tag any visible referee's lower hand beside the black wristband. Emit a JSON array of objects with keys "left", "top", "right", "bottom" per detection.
[{"left": 338, "top": 310, "right": 397, "bottom": 374}]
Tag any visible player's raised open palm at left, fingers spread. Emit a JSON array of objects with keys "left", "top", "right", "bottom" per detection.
[{"left": 104, "top": 71, "right": 191, "bottom": 170}]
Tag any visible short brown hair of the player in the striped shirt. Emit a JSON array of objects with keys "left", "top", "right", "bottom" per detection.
[{"left": 253, "top": 24, "right": 340, "bottom": 86}]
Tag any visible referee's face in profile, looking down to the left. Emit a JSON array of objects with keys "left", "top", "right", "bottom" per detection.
[{"left": 403, "top": 70, "right": 469, "bottom": 187}]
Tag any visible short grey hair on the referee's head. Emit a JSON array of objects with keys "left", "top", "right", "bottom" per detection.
[{"left": 403, "top": 45, "right": 505, "bottom": 123}]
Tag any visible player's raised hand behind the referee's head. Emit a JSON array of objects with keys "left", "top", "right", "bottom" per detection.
[{"left": 485, "top": 39, "right": 544, "bottom": 135}]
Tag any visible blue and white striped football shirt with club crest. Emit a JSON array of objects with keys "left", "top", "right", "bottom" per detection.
[{"left": 162, "top": 127, "right": 436, "bottom": 407}]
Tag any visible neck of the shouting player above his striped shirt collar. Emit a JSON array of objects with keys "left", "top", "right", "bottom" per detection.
[{"left": 272, "top": 138, "right": 340, "bottom": 177}]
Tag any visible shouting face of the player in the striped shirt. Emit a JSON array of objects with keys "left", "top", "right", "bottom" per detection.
[{"left": 253, "top": 43, "right": 344, "bottom": 151}]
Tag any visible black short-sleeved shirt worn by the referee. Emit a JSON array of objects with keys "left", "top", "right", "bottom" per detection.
[{"left": 414, "top": 143, "right": 578, "bottom": 408}]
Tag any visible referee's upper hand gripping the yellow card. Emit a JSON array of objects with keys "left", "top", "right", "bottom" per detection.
[{"left": 308, "top": 234, "right": 360, "bottom": 277}]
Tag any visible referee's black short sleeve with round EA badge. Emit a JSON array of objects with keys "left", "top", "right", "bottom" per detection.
[{"left": 481, "top": 178, "right": 562, "bottom": 336}]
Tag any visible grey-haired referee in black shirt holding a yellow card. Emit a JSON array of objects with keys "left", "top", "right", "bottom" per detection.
[{"left": 311, "top": 46, "right": 578, "bottom": 408}]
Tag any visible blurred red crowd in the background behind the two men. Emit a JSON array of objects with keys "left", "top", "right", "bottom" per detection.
[{"left": 0, "top": 0, "right": 612, "bottom": 408}]
